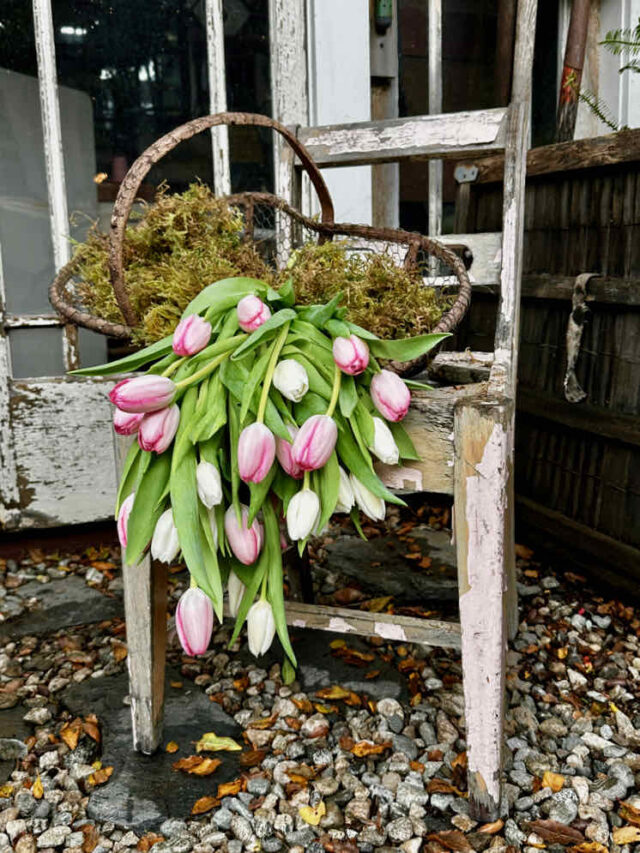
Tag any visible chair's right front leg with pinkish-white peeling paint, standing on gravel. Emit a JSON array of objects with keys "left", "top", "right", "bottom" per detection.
[{"left": 454, "top": 400, "right": 513, "bottom": 821}]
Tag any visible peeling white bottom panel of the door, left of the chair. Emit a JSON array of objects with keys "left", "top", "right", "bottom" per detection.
[{"left": 3, "top": 377, "right": 116, "bottom": 527}]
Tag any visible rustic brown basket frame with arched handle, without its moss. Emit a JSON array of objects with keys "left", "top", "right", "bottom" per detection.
[{"left": 49, "top": 113, "right": 471, "bottom": 373}]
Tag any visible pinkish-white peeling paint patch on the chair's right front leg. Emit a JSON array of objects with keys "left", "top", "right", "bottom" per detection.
[{"left": 460, "top": 416, "right": 508, "bottom": 803}]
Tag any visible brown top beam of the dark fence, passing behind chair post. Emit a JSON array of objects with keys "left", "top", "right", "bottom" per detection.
[{"left": 464, "top": 129, "right": 640, "bottom": 184}]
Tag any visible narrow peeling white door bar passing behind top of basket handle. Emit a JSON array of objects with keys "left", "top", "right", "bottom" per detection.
[{"left": 205, "top": 0, "right": 231, "bottom": 195}]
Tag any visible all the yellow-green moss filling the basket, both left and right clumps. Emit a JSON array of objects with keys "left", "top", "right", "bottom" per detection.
[{"left": 76, "top": 183, "right": 447, "bottom": 344}]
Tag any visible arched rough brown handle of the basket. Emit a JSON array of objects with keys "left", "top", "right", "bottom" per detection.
[{"left": 109, "top": 113, "right": 334, "bottom": 326}]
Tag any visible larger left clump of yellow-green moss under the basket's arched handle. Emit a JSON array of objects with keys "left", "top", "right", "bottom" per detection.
[{"left": 76, "top": 184, "right": 273, "bottom": 344}]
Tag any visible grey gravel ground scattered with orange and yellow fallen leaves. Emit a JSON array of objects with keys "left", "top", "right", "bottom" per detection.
[{"left": 0, "top": 508, "right": 640, "bottom": 853}]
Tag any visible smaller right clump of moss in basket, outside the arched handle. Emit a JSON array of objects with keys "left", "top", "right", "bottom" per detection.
[{"left": 287, "top": 241, "right": 447, "bottom": 338}]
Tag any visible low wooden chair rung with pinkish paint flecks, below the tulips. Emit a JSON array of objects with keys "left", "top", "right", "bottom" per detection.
[{"left": 286, "top": 601, "right": 460, "bottom": 649}]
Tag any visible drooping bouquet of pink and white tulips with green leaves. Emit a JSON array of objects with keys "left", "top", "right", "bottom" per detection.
[{"left": 76, "top": 278, "right": 445, "bottom": 676}]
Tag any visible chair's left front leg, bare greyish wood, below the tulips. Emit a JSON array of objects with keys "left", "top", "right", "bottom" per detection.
[{"left": 122, "top": 556, "right": 167, "bottom": 755}]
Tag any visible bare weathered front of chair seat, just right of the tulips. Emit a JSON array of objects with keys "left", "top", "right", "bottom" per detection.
[{"left": 376, "top": 382, "right": 487, "bottom": 495}]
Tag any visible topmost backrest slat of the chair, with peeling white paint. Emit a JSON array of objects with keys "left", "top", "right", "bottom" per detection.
[{"left": 299, "top": 107, "right": 507, "bottom": 166}]
